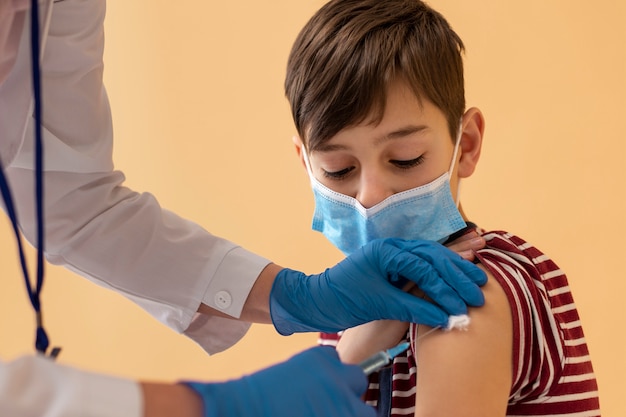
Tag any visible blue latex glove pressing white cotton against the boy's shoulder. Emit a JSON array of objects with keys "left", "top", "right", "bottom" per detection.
[{"left": 270, "top": 238, "right": 487, "bottom": 335}]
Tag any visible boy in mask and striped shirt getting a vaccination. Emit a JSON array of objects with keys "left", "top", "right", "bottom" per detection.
[{"left": 285, "top": 0, "right": 600, "bottom": 417}]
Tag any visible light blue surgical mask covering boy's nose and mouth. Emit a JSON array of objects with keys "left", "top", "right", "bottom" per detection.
[{"left": 304, "top": 125, "right": 466, "bottom": 255}]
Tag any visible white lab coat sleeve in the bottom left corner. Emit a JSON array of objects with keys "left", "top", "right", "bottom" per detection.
[{"left": 0, "top": 356, "right": 143, "bottom": 417}]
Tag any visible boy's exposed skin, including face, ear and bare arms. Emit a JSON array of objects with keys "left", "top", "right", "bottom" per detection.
[{"left": 294, "top": 80, "right": 513, "bottom": 417}]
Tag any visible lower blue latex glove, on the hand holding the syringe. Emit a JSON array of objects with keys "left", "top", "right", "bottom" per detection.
[{"left": 183, "top": 346, "right": 376, "bottom": 417}]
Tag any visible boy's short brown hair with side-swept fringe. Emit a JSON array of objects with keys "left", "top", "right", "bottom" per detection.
[{"left": 285, "top": 0, "right": 465, "bottom": 149}]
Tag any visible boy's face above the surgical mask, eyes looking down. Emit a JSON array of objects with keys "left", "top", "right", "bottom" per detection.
[{"left": 295, "top": 82, "right": 462, "bottom": 208}]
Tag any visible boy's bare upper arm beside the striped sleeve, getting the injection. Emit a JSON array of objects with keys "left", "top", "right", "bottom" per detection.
[{"left": 414, "top": 268, "right": 513, "bottom": 417}]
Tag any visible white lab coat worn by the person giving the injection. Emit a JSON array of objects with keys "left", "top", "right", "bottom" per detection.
[{"left": 0, "top": 0, "right": 269, "bottom": 417}]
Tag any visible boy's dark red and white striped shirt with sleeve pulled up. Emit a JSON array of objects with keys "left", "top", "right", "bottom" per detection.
[{"left": 320, "top": 231, "right": 600, "bottom": 417}]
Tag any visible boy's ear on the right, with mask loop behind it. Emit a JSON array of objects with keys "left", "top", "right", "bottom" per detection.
[{"left": 457, "top": 107, "right": 485, "bottom": 178}]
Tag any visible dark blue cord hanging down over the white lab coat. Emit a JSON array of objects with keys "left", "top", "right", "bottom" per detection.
[{"left": 0, "top": 0, "right": 61, "bottom": 358}]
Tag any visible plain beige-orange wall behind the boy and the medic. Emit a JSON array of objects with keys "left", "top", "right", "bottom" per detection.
[{"left": 0, "top": 0, "right": 626, "bottom": 417}]
